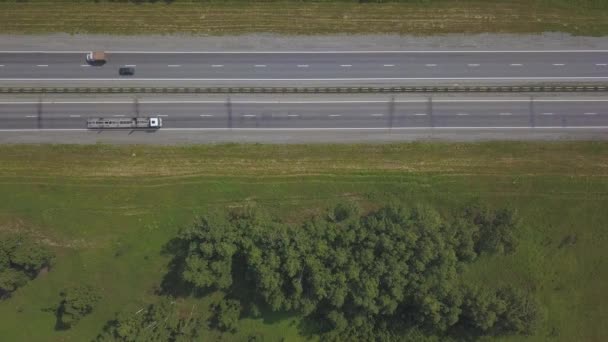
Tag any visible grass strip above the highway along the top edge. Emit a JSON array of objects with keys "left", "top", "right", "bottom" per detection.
[{"left": 0, "top": 0, "right": 608, "bottom": 35}]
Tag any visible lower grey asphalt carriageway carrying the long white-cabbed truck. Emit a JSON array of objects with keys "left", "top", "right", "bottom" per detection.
[{"left": 0, "top": 96, "right": 608, "bottom": 133}]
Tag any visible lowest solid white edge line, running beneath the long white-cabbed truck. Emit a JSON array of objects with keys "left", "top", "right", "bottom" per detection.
[{"left": 0, "top": 126, "right": 608, "bottom": 132}]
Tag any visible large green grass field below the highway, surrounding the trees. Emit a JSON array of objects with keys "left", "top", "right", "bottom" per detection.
[{"left": 0, "top": 142, "right": 608, "bottom": 342}]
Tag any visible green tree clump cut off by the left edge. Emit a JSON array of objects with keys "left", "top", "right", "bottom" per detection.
[{"left": 0, "top": 234, "right": 52, "bottom": 298}]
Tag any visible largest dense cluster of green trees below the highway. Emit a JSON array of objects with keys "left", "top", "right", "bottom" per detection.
[{"left": 159, "top": 203, "right": 538, "bottom": 340}]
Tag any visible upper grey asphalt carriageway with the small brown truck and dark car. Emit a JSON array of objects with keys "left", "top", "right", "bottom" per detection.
[{"left": 0, "top": 50, "right": 608, "bottom": 82}]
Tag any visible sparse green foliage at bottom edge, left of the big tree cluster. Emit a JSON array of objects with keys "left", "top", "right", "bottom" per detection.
[{"left": 96, "top": 297, "right": 200, "bottom": 342}]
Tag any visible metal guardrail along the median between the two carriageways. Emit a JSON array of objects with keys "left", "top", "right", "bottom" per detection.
[{"left": 0, "top": 85, "right": 608, "bottom": 94}]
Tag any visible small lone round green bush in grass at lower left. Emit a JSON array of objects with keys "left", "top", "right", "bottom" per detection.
[{"left": 56, "top": 285, "right": 101, "bottom": 329}]
